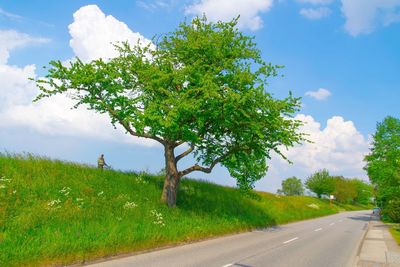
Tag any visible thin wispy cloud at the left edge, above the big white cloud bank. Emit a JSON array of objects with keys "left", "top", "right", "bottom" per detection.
[{"left": 0, "top": 30, "right": 50, "bottom": 64}]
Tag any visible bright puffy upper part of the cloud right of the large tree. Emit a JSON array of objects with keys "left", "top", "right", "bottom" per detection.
[{"left": 286, "top": 114, "right": 368, "bottom": 176}]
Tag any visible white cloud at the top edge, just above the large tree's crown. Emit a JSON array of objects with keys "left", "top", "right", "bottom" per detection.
[{"left": 185, "top": 0, "right": 273, "bottom": 31}]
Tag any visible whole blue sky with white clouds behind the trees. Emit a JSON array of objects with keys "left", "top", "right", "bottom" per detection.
[{"left": 0, "top": 0, "right": 400, "bottom": 192}]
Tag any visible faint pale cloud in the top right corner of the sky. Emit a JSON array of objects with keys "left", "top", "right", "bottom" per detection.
[{"left": 342, "top": 0, "right": 400, "bottom": 36}]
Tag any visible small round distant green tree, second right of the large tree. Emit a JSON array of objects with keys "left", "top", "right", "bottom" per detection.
[{"left": 305, "top": 169, "right": 335, "bottom": 198}]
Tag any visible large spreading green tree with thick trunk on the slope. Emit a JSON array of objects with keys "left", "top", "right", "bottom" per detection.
[{"left": 36, "top": 17, "right": 304, "bottom": 207}]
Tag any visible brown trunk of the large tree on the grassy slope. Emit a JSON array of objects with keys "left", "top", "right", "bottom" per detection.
[{"left": 161, "top": 144, "right": 180, "bottom": 207}]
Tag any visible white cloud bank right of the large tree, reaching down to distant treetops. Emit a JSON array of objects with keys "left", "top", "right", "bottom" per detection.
[{"left": 256, "top": 114, "right": 369, "bottom": 192}]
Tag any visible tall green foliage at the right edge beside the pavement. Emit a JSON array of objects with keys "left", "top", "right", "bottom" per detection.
[{"left": 365, "top": 116, "right": 400, "bottom": 223}]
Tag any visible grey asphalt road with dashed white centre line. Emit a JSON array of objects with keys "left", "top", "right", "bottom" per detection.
[{"left": 91, "top": 211, "right": 371, "bottom": 267}]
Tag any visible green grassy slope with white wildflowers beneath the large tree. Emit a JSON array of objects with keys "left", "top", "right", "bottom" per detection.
[{"left": 0, "top": 155, "right": 368, "bottom": 266}]
